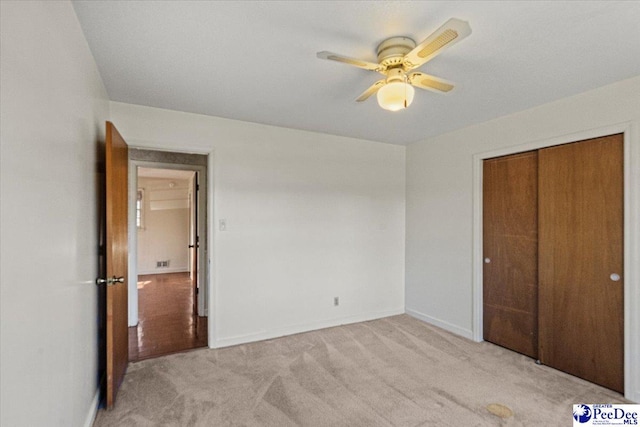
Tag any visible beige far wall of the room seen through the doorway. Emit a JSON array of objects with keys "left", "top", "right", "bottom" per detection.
[{"left": 138, "top": 177, "right": 189, "bottom": 274}]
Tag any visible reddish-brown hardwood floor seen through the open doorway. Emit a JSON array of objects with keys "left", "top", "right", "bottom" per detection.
[{"left": 129, "top": 273, "right": 207, "bottom": 362}]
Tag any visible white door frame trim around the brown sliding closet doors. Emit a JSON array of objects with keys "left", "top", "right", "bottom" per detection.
[{"left": 472, "top": 122, "right": 640, "bottom": 402}]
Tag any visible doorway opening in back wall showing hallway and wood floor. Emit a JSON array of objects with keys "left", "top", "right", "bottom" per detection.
[{"left": 129, "top": 150, "right": 208, "bottom": 361}]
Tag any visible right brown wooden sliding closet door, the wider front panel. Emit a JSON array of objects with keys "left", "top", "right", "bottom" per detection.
[{"left": 538, "top": 135, "right": 624, "bottom": 393}]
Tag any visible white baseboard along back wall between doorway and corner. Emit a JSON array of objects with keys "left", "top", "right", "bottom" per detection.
[{"left": 215, "top": 308, "right": 404, "bottom": 348}]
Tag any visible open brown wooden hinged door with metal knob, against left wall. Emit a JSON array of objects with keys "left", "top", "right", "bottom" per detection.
[{"left": 105, "top": 122, "right": 129, "bottom": 408}]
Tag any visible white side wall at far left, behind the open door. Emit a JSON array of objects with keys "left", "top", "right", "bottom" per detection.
[{"left": 0, "top": 1, "right": 109, "bottom": 427}]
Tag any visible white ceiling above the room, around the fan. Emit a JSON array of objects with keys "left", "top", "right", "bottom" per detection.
[{"left": 73, "top": 0, "right": 640, "bottom": 144}]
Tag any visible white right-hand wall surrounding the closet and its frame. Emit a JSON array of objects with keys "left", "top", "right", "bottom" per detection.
[{"left": 405, "top": 77, "right": 640, "bottom": 401}]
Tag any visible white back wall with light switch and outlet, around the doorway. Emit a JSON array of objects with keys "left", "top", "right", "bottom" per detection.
[{"left": 111, "top": 102, "right": 405, "bottom": 346}]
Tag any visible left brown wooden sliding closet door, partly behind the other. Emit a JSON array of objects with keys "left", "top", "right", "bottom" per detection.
[{"left": 483, "top": 151, "right": 538, "bottom": 358}]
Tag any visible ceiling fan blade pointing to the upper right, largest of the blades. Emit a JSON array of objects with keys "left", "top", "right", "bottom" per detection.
[{"left": 404, "top": 18, "right": 471, "bottom": 70}]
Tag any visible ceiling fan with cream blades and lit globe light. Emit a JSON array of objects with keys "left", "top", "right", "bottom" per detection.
[{"left": 317, "top": 18, "right": 471, "bottom": 111}]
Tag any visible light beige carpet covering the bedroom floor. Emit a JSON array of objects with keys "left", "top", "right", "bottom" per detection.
[{"left": 95, "top": 315, "right": 625, "bottom": 427}]
